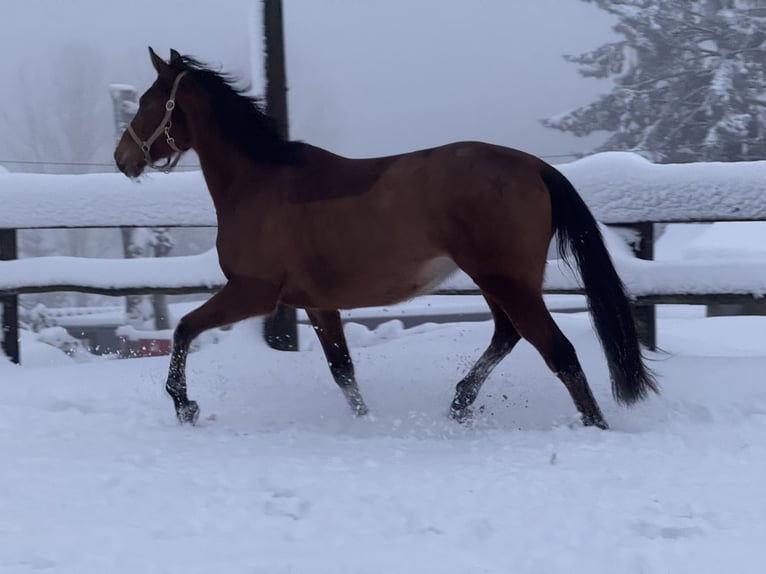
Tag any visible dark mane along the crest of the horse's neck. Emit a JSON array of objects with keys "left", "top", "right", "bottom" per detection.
[{"left": 171, "top": 56, "right": 301, "bottom": 164}]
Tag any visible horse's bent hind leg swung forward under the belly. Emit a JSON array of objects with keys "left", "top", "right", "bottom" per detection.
[{"left": 450, "top": 294, "right": 521, "bottom": 422}]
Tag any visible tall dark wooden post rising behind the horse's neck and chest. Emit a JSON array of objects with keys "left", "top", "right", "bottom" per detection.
[{"left": 263, "top": 0, "right": 298, "bottom": 351}]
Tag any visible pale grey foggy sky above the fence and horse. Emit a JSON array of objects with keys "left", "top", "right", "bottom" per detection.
[{"left": 0, "top": 0, "right": 613, "bottom": 165}]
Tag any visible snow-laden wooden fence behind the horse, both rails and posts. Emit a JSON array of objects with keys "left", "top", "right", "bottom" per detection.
[{"left": 0, "top": 152, "right": 766, "bottom": 362}]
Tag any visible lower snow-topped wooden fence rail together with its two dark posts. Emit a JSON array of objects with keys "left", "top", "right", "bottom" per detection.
[{"left": 0, "top": 218, "right": 766, "bottom": 362}]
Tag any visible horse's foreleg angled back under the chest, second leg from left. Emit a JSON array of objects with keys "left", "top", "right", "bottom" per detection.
[{"left": 306, "top": 309, "right": 367, "bottom": 416}]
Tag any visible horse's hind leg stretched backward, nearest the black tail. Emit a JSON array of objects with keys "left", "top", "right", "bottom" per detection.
[{"left": 476, "top": 276, "right": 608, "bottom": 429}]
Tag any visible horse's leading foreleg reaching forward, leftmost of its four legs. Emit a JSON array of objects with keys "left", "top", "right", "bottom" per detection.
[{"left": 165, "top": 280, "right": 278, "bottom": 424}]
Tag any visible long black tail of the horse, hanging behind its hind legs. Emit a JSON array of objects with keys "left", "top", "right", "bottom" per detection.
[{"left": 541, "top": 165, "right": 659, "bottom": 405}]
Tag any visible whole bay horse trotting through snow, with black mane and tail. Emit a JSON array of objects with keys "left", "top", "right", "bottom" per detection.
[{"left": 114, "top": 48, "right": 657, "bottom": 429}]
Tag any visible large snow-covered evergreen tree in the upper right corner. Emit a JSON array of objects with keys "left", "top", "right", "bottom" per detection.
[{"left": 543, "top": 0, "right": 766, "bottom": 163}]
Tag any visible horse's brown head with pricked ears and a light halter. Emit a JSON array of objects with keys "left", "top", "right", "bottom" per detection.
[{"left": 114, "top": 48, "right": 191, "bottom": 177}]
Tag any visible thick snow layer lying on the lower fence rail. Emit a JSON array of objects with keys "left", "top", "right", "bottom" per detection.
[{"left": 0, "top": 224, "right": 766, "bottom": 297}]
